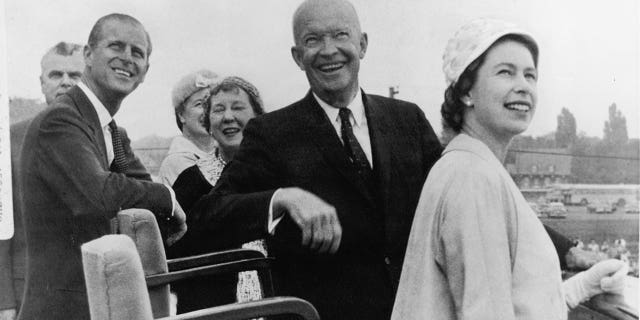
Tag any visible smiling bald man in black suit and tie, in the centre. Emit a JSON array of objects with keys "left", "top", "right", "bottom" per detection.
[{"left": 189, "top": 0, "right": 441, "bottom": 320}]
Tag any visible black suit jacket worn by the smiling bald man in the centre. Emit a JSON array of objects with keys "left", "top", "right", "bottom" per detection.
[{"left": 190, "top": 92, "right": 441, "bottom": 320}]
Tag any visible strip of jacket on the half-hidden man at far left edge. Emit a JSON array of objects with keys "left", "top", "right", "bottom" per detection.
[{"left": 0, "top": 119, "right": 31, "bottom": 310}]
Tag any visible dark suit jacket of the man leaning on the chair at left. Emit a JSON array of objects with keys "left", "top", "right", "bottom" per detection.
[{"left": 20, "top": 87, "right": 172, "bottom": 319}]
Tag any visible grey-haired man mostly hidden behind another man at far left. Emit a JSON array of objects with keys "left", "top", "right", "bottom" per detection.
[{"left": 0, "top": 42, "right": 84, "bottom": 320}]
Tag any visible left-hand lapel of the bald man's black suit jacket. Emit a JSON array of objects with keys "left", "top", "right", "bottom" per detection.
[{"left": 301, "top": 91, "right": 373, "bottom": 201}]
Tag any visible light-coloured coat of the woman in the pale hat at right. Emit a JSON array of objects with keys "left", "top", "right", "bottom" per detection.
[{"left": 392, "top": 134, "right": 567, "bottom": 320}]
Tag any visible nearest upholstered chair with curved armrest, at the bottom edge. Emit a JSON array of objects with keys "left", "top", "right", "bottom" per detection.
[{"left": 81, "top": 235, "right": 319, "bottom": 320}]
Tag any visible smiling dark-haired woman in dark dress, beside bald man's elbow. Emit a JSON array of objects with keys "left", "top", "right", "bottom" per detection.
[{"left": 167, "top": 77, "right": 266, "bottom": 313}]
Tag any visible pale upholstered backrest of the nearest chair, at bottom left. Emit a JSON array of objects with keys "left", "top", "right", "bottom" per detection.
[{"left": 81, "top": 235, "right": 153, "bottom": 320}]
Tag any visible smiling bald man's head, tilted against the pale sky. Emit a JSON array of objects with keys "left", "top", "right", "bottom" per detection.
[{"left": 291, "top": 0, "right": 368, "bottom": 108}]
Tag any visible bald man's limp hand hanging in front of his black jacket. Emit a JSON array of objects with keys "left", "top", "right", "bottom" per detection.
[{"left": 273, "top": 188, "right": 342, "bottom": 253}]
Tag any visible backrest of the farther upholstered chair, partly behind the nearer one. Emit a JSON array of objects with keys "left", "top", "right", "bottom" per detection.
[{"left": 117, "top": 209, "right": 171, "bottom": 318}]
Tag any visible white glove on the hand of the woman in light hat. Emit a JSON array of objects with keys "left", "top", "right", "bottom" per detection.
[{"left": 562, "top": 259, "right": 629, "bottom": 309}]
